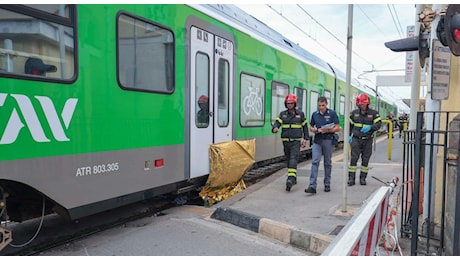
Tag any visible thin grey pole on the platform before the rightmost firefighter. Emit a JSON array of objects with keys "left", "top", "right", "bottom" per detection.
[{"left": 342, "top": 5, "right": 353, "bottom": 212}]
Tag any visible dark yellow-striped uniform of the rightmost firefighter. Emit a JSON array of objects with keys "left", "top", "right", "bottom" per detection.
[{"left": 348, "top": 108, "right": 382, "bottom": 186}]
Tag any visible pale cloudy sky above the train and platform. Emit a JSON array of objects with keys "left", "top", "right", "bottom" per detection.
[{"left": 237, "top": 4, "right": 423, "bottom": 110}]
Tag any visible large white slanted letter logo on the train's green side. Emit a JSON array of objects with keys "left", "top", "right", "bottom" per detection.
[{"left": 0, "top": 93, "right": 78, "bottom": 145}]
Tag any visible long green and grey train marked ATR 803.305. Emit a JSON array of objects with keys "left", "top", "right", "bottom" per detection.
[{"left": 0, "top": 4, "right": 394, "bottom": 230}]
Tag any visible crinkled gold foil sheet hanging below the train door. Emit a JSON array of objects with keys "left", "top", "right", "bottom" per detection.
[{"left": 200, "top": 139, "right": 256, "bottom": 205}]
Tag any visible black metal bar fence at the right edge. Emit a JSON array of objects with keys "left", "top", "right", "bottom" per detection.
[{"left": 400, "top": 111, "right": 460, "bottom": 256}]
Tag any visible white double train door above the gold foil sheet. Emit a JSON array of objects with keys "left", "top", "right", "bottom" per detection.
[{"left": 189, "top": 26, "right": 233, "bottom": 178}]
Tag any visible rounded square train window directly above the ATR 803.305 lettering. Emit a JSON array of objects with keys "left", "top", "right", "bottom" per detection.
[{"left": 117, "top": 14, "right": 175, "bottom": 93}]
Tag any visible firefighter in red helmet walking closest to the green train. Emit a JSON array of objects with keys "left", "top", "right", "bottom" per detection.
[{"left": 272, "top": 94, "right": 310, "bottom": 191}]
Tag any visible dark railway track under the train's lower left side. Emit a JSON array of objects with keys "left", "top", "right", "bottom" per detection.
[{"left": 0, "top": 195, "right": 178, "bottom": 256}]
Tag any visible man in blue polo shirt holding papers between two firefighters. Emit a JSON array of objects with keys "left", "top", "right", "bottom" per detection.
[{"left": 305, "top": 97, "right": 340, "bottom": 194}]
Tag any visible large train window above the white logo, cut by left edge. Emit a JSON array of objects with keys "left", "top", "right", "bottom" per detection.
[{"left": 0, "top": 4, "right": 75, "bottom": 81}]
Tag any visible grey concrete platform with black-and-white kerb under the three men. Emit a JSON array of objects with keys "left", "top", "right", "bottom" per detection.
[{"left": 211, "top": 133, "right": 410, "bottom": 256}]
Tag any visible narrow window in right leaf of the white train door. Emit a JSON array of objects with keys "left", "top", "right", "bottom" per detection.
[{"left": 217, "top": 59, "right": 230, "bottom": 127}]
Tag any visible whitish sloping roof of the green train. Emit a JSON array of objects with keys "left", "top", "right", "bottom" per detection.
[{"left": 193, "top": 4, "right": 334, "bottom": 75}]
